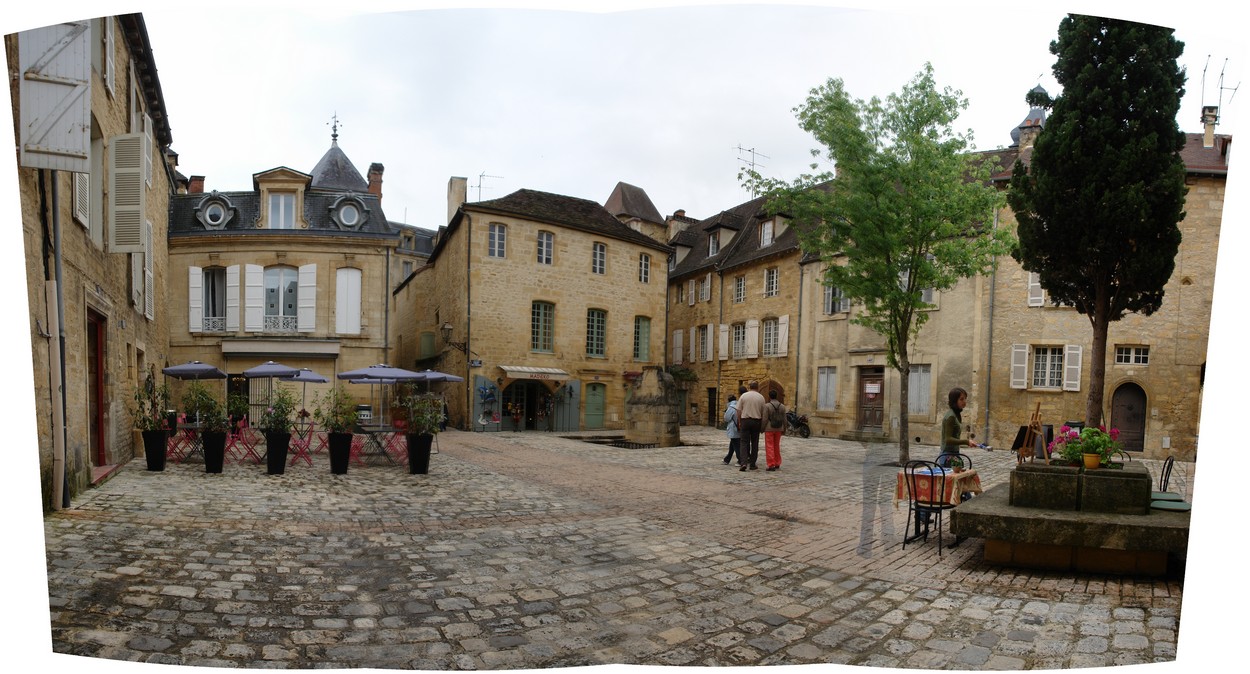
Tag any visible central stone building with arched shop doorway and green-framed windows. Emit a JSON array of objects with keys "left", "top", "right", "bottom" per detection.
[{"left": 394, "top": 178, "right": 670, "bottom": 430}]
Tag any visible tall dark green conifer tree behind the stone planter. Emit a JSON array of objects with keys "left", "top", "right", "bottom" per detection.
[{"left": 1008, "top": 14, "right": 1185, "bottom": 426}]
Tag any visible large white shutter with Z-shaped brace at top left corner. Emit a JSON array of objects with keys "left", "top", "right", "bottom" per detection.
[{"left": 18, "top": 21, "right": 91, "bottom": 174}]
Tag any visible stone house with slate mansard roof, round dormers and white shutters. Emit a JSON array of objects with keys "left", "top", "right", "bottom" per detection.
[{"left": 169, "top": 130, "right": 401, "bottom": 413}]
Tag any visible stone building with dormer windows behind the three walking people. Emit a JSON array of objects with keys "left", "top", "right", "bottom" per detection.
[{"left": 669, "top": 198, "right": 803, "bottom": 425}]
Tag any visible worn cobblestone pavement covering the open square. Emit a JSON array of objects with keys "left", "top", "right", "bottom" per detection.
[{"left": 44, "top": 426, "right": 1193, "bottom": 669}]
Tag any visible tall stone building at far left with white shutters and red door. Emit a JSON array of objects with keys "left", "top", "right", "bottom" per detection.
[{"left": 5, "top": 14, "right": 175, "bottom": 509}]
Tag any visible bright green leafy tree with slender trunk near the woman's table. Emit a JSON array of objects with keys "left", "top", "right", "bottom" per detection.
[{"left": 744, "top": 64, "right": 1014, "bottom": 463}]
